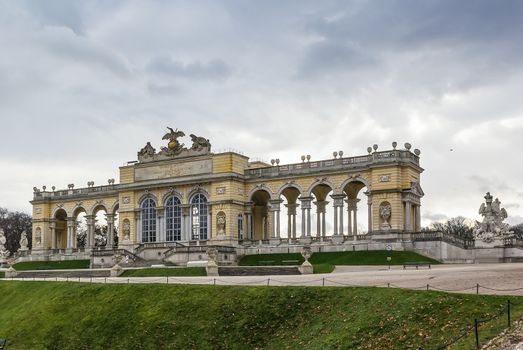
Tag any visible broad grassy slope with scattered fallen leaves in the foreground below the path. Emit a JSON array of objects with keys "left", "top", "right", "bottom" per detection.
[{"left": 0, "top": 281, "right": 522, "bottom": 350}]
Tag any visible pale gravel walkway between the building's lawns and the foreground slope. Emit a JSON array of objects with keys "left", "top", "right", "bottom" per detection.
[{"left": 8, "top": 263, "right": 523, "bottom": 295}]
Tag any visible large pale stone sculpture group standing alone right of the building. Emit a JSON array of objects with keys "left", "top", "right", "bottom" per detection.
[{"left": 474, "top": 192, "right": 512, "bottom": 246}]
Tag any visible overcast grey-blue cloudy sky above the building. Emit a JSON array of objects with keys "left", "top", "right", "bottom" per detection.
[{"left": 0, "top": 0, "right": 523, "bottom": 224}]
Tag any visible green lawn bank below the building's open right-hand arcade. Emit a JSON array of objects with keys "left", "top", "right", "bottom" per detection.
[{"left": 238, "top": 250, "right": 440, "bottom": 273}]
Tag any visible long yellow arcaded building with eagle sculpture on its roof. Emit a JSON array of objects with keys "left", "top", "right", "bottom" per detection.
[{"left": 31, "top": 129, "right": 423, "bottom": 253}]
